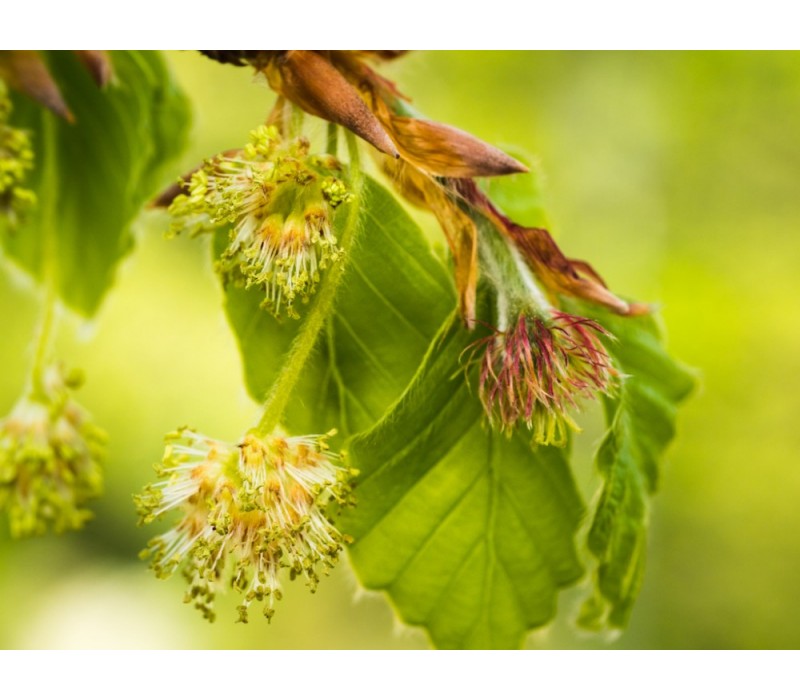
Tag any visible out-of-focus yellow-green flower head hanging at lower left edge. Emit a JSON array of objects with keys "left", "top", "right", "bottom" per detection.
[{"left": 0, "top": 365, "right": 105, "bottom": 537}]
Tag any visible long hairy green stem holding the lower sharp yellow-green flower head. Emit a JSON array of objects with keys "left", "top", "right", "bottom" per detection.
[{"left": 254, "top": 132, "right": 364, "bottom": 436}]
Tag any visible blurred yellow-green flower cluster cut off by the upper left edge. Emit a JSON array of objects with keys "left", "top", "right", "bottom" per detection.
[{"left": 0, "top": 80, "right": 36, "bottom": 224}]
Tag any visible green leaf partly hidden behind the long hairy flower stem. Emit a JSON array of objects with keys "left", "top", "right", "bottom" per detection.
[{"left": 215, "top": 175, "right": 455, "bottom": 436}]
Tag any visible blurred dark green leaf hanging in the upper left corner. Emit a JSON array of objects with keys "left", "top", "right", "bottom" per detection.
[{"left": 3, "top": 51, "right": 189, "bottom": 316}]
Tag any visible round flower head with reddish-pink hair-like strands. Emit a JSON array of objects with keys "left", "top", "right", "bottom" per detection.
[{"left": 473, "top": 310, "right": 615, "bottom": 444}]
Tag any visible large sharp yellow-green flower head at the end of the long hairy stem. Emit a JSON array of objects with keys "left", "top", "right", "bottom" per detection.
[{"left": 135, "top": 429, "right": 352, "bottom": 622}]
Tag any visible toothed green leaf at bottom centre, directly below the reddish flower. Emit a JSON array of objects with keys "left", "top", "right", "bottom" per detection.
[{"left": 343, "top": 320, "right": 583, "bottom": 648}]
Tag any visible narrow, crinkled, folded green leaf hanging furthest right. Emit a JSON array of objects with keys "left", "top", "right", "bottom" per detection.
[{"left": 579, "top": 308, "right": 695, "bottom": 629}]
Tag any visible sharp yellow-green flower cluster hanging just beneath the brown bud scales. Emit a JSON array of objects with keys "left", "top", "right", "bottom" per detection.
[{"left": 169, "top": 126, "right": 352, "bottom": 317}]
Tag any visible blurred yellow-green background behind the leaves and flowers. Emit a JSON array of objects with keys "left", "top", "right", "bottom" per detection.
[{"left": 0, "top": 52, "right": 800, "bottom": 648}]
